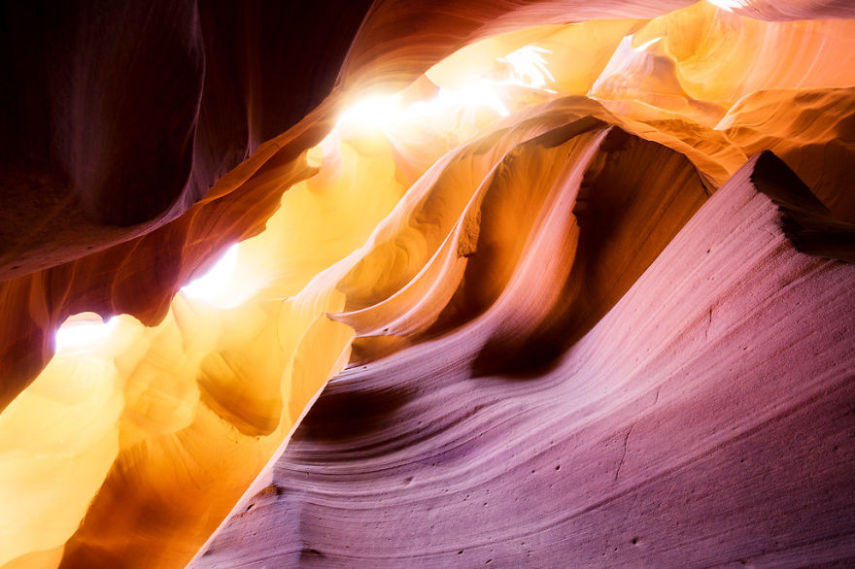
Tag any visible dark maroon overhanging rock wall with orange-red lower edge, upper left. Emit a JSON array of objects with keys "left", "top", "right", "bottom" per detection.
[{"left": 0, "top": 0, "right": 704, "bottom": 407}]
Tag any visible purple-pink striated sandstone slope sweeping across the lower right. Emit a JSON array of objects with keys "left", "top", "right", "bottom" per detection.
[{"left": 190, "top": 155, "right": 855, "bottom": 567}]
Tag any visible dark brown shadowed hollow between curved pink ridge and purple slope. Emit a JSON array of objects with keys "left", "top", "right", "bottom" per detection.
[{"left": 473, "top": 128, "right": 708, "bottom": 379}]
